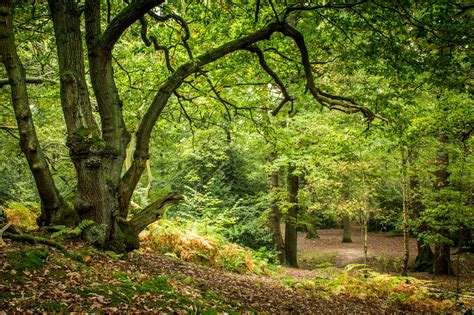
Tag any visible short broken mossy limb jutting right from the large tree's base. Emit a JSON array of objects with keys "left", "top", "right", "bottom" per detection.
[{"left": 128, "top": 192, "right": 183, "bottom": 234}]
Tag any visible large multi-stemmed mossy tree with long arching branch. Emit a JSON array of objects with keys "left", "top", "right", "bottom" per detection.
[{"left": 0, "top": 0, "right": 468, "bottom": 259}]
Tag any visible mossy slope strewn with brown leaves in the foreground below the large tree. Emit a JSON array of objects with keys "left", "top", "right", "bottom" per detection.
[{"left": 0, "top": 232, "right": 473, "bottom": 314}]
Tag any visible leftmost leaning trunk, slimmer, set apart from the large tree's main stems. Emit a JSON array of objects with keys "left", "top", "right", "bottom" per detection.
[{"left": 0, "top": 1, "right": 78, "bottom": 226}]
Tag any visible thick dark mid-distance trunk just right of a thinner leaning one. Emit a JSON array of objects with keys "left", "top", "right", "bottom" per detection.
[{"left": 285, "top": 164, "right": 299, "bottom": 268}]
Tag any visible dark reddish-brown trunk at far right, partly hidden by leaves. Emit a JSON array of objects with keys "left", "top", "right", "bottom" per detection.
[{"left": 433, "top": 135, "right": 452, "bottom": 275}]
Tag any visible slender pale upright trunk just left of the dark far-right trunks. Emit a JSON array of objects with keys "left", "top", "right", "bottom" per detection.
[{"left": 400, "top": 146, "right": 410, "bottom": 276}]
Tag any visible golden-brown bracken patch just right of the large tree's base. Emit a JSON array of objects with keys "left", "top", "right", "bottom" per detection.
[{"left": 140, "top": 220, "right": 278, "bottom": 274}]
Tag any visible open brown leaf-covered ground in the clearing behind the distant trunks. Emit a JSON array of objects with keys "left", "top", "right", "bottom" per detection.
[{"left": 298, "top": 226, "right": 474, "bottom": 299}]
